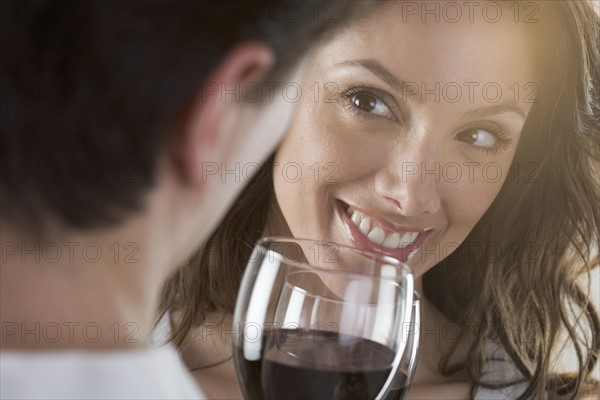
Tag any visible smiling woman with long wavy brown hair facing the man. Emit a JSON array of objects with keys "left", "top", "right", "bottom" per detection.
[{"left": 163, "top": 2, "right": 600, "bottom": 399}]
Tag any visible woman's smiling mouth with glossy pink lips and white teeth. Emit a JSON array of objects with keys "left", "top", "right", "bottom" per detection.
[{"left": 337, "top": 201, "right": 431, "bottom": 262}]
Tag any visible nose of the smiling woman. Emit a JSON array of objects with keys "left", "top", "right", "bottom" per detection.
[{"left": 375, "top": 161, "right": 441, "bottom": 217}]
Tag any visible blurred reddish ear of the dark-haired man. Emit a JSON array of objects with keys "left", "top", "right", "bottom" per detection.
[{"left": 174, "top": 42, "right": 275, "bottom": 186}]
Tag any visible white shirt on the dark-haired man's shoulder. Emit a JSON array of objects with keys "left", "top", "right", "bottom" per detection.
[{"left": 0, "top": 345, "right": 204, "bottom": 399}]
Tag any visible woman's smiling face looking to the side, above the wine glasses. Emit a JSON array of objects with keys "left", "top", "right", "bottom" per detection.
[{"left": 273, "top": 2, "right": 537, "bottom": 276}]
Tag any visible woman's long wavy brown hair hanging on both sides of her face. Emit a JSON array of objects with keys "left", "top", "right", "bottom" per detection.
[{"left": 162, "top": 1, "right": 600, "bottom": 399}]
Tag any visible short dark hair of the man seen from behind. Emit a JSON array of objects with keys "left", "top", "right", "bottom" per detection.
[{"left": 0, "top": 0, "right": 362, "bottom": 228}]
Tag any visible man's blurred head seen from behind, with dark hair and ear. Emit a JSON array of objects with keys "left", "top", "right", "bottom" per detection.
[{"left": 0, "top": 0, "right": 370, "bottom": 268}]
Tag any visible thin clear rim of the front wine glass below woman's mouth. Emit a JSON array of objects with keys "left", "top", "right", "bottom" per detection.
[{"left": 255, "top": 236, "right": 413, "bottom": 276}]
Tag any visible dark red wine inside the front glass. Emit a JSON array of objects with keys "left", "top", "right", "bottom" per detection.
[{"left": 236, "top": 330, "right": 394, "bottom": 400}]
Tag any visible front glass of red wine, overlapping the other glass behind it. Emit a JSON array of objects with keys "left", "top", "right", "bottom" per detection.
[{"left": 233, "top": 238, "right": 418, "bottom": 400}]
